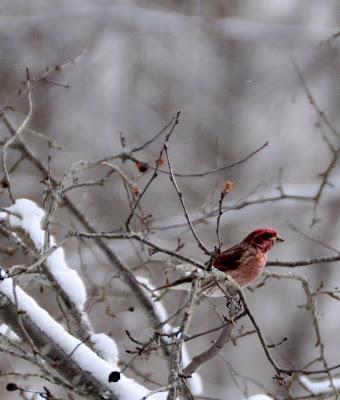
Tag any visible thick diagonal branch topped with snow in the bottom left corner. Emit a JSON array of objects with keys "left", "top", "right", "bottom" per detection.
[{"left": 0, "top": 278, "right": 164, "bottom": 400}]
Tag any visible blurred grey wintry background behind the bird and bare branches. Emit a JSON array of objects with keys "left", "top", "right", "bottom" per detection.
[{"left": 0, "top": 0, "right": 340, "bottom": 400}]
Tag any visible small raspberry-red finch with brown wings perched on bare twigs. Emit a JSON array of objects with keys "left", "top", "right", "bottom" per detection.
[{"left": 155, "top": 228, "right": 284, "bottom": 297}]
